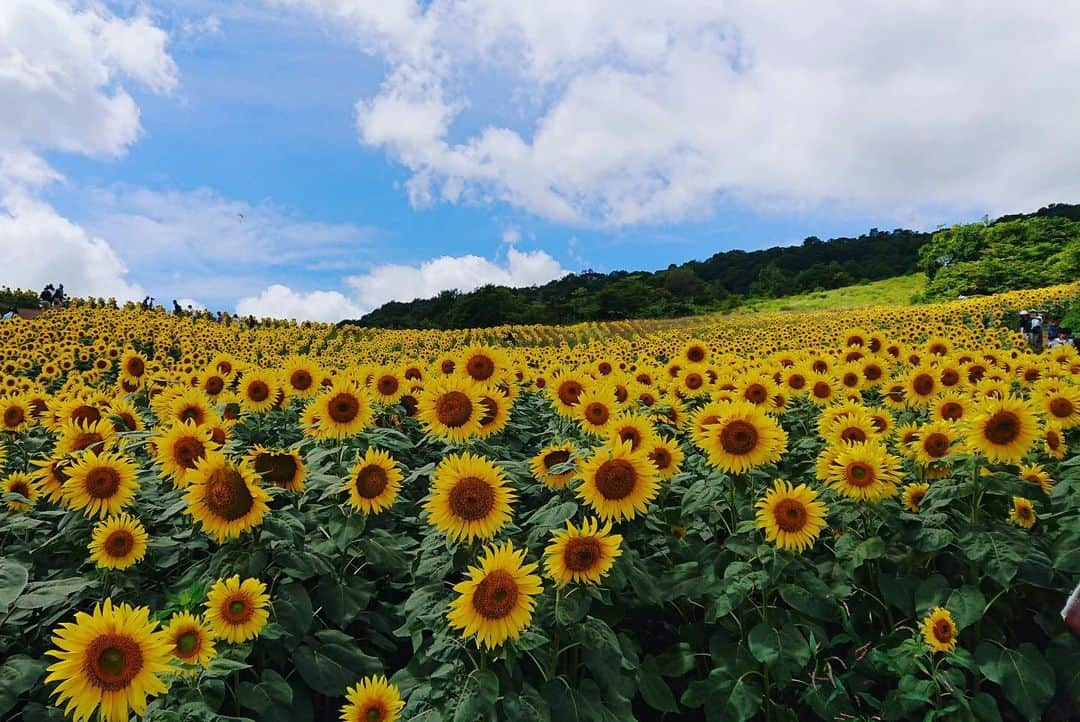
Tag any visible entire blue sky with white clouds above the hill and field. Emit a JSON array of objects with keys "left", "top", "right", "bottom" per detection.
[{"left": 0, "top": 0, "right": 1080, "bottom": 321}]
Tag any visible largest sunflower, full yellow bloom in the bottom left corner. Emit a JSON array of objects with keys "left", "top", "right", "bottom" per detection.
[{"left": 45, "top": 599, "right": 168, "bottom": 722}]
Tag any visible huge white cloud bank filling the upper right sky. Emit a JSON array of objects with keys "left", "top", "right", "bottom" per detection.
[{"left": 271, "top": 0, "right": 1080, "bottom": 226}]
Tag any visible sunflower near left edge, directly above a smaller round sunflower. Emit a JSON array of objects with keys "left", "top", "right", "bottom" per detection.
[{"left": 64, "top": 451, "right": 138, "bottom": 518}]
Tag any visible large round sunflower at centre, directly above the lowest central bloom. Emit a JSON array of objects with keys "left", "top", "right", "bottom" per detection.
[{"left": 424, "top": 453, "right": 515, "bottom": 542}]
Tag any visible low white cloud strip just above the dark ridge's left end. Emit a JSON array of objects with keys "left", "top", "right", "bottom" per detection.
[{"left": 237, "top": 247, "right": 568, "bottom": 321}]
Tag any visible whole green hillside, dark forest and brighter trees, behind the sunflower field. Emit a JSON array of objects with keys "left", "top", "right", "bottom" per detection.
[{"left": 342, "top": 204, "right": 1080, "bottom": 329}]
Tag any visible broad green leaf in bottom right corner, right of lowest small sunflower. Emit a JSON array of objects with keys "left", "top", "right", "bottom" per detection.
[{"left": 975, "top": 642, "right": 1054, "bottom": 720}]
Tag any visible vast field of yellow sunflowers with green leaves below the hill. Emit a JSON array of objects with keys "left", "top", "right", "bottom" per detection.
[{"left": 0, "top": 285, "right": 1080, "bottom": 722}]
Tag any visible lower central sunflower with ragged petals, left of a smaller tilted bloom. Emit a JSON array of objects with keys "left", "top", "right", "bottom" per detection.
[{"left": 446, "top": 542, "right": 542, "bottom": 649}]
